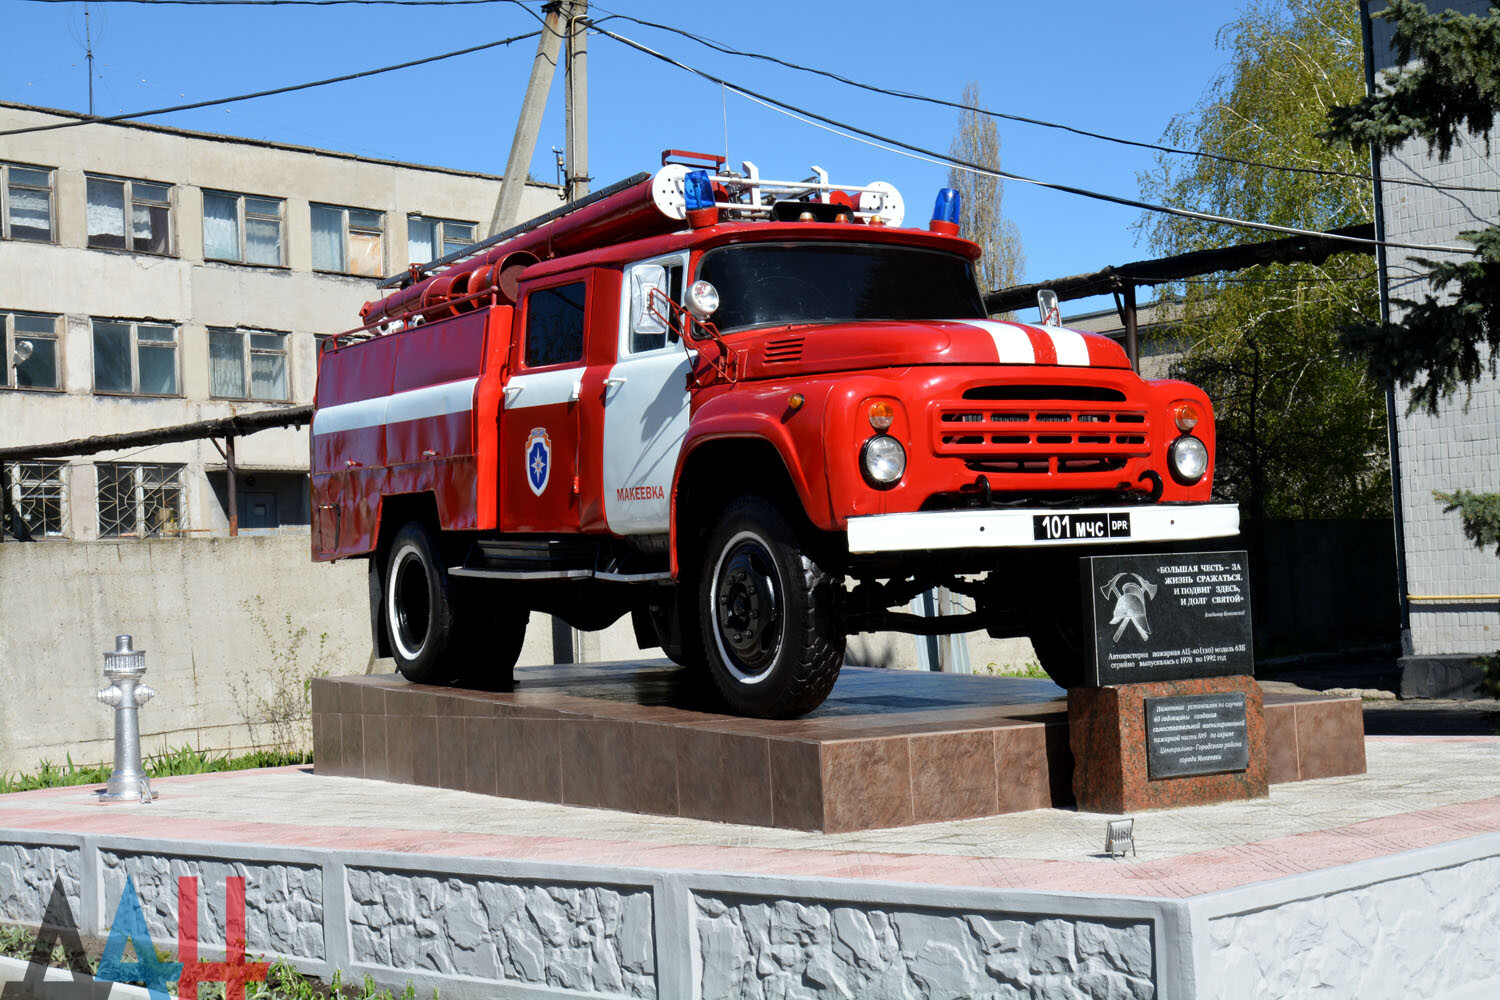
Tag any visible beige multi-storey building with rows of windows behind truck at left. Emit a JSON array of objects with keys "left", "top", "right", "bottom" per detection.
[{"left": 0, "top": 103, "right": 561, "bottom": 540}]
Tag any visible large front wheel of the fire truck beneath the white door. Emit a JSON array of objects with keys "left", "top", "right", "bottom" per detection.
[{"left": 698, "top": 496, "right": 845, "bottom": 718}]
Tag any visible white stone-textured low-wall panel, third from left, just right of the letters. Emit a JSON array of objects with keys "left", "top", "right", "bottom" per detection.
[{"left": 348, "top": 868, "right": 657, "bottom": 997}]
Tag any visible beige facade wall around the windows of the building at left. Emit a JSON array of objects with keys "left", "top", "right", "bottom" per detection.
[{"left": 0, "top": 103, "right": 560, "bottom": 538}]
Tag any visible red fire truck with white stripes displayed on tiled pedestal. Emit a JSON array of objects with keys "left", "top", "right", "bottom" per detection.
[{"left": 312, "top": 151, "right": 1239, "bottom": 717}]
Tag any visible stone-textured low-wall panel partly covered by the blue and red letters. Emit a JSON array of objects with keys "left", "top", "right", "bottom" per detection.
[{"left": 99, "top": 850, "right": 327, "bottom": 961}]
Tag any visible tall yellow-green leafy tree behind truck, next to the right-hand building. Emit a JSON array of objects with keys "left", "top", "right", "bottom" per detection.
[{"left": 1142, "top": 0, "right": 1391, "bottom": 517}]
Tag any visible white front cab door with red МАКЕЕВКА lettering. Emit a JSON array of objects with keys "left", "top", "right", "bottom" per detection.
[{"left": 602, "top": 252, "right": 692, "bottom": 535}]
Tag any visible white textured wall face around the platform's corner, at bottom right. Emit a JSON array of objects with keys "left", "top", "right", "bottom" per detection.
[{"left": 1200, "top": 858, "right": 1500, "bottom": 1000}]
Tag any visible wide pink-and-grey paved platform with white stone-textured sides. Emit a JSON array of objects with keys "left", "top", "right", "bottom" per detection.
[{"left": 0, "top": 740, "right": 1500, "bottom": 1000}]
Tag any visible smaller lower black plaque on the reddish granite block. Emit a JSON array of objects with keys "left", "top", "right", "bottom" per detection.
[{"left": 1145, "top": 691, "right": 1250, "bottom": 778}]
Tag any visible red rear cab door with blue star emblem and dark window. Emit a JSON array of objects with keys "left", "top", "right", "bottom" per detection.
[{"left": 500, "top": 274, "right": 591, "bottom": 532}]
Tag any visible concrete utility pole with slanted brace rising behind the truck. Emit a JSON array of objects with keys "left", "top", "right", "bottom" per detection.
[{"left": 489, "top": 0, "right": 588, "bottom": 235}]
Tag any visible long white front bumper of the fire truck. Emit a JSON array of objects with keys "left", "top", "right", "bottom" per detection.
[{"left": 849, "top": 504, "right": 1239, "bottom": 555}]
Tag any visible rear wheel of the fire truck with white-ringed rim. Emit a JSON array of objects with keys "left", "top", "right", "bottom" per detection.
[{"left": 381, "top": 522, "right": 459, "bottom": 684}]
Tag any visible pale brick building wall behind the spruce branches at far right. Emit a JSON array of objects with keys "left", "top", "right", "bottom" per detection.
[{"left": 1374, "top": 13, "right": 1500, "bottom": 657}]
